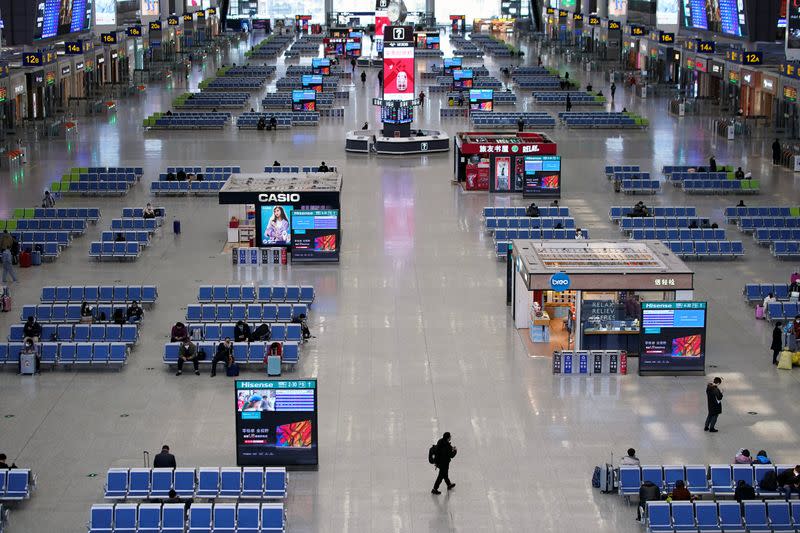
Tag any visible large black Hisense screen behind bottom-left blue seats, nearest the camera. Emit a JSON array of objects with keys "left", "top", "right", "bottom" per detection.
[{"left": 235, "top": 379, "right": 319, "bottom": 467}]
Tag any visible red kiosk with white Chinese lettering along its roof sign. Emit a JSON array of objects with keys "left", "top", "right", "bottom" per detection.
[{"left": 453, "top": 131, "right": 561, "bottom": 192}]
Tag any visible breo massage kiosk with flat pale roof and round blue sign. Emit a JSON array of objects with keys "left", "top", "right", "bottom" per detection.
[{"left": 507, "top": 240, "right": 694, "bottom": 355}]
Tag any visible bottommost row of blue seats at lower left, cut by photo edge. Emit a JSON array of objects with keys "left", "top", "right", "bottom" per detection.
[{"left": 88, "top": 503, "right": 286, "bottom": 533}]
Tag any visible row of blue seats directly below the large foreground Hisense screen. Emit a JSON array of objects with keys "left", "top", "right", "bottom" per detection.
[{"left": 105, "top": 466, "right": 288, "bottom": 500}]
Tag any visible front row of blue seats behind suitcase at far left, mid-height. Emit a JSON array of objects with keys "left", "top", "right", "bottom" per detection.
[{"left": 0, "top": 342, "right": 128, "bottom": 366}]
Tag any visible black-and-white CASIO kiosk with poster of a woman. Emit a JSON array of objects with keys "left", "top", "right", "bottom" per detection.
[{"left": 219, "top": 168, "right": 342, "bottom": 264}]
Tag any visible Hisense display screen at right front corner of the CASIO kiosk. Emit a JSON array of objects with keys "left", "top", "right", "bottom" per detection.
[{"left": 292, "top": 209, "right": 339, "bottom": 262}]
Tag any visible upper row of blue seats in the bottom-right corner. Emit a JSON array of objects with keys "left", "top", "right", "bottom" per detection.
[{"left": 619, "top": 464, "right": 795, "bottom": 497}]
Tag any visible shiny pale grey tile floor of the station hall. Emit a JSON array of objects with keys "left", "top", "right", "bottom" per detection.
[{"left": 0, "top": 33, "right": 800, "bottom": 533}]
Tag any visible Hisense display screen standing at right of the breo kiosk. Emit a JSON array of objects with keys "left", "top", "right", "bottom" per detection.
[{"left": 639, "top": 302, "right": 707, "bottom": 374}]
